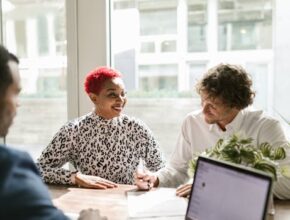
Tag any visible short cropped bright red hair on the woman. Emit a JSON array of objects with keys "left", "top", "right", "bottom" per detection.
[{"left": 84, "top": 66, "right": 122, "bottom": 94}]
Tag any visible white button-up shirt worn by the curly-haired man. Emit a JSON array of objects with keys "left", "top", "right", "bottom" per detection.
[{"left": 157, "top": 109, "right": 290, "bottom": 199}]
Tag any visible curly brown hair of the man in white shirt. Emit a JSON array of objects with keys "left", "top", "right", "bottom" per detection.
[{"left": 196, "top": 64, "right": 255, "bottom": 109}]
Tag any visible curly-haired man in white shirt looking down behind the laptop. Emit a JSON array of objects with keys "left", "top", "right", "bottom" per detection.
[{"left": 135, "top": 64, "right": 290, "bottom": 199}]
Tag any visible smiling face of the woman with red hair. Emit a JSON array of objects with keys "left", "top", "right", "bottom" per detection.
[{"left": 89, "top": 77, "right": 127, "bottom": 119}]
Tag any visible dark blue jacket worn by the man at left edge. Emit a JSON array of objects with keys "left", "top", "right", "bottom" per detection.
[{"left": 0, "top": 145, "right": 68, "bottom": 220}]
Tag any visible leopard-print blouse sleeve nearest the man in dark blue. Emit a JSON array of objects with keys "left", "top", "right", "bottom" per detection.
[{"left": 37, "top": 123, "right": 77, "bottom": 185}]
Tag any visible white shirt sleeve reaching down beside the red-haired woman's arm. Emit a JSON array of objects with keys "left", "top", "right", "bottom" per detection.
[{"left": 157, "top": 117, "right": 193, "bottom": 187}]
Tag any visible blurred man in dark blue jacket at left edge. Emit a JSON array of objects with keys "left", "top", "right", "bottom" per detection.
[{"left": 0, "top": 45, "right": 107, "bottom": 220}]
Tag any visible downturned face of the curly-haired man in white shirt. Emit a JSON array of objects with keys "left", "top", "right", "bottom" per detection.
[{"left": 200, "top": 92, "right": 239, "bottom": 129}]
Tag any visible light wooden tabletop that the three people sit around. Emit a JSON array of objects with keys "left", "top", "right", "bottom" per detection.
[{"left": 48, "top": 185, "right": 290, "bottom": 220}]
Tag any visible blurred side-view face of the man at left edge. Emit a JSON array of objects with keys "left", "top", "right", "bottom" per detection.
[{"left": 0, "top": 61, "right": 21, "bottom": 137}]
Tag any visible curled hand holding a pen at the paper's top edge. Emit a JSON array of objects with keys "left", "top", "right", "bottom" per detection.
[{"left": 134, "top": 170, "right": 159, "bottom": 190}]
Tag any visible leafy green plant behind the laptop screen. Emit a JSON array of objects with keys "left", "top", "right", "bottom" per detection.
[{"left": 188, "top": 135, "right": 290, "bottom": 180}]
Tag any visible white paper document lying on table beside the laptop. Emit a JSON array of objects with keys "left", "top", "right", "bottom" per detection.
[{"left": 127, "top": 188, "right": 188, "bottom": 218}]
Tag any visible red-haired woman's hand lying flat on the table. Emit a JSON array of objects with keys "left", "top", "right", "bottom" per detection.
[{"left": 74, "top": 173, "right": 118, "bottom": 189}]
